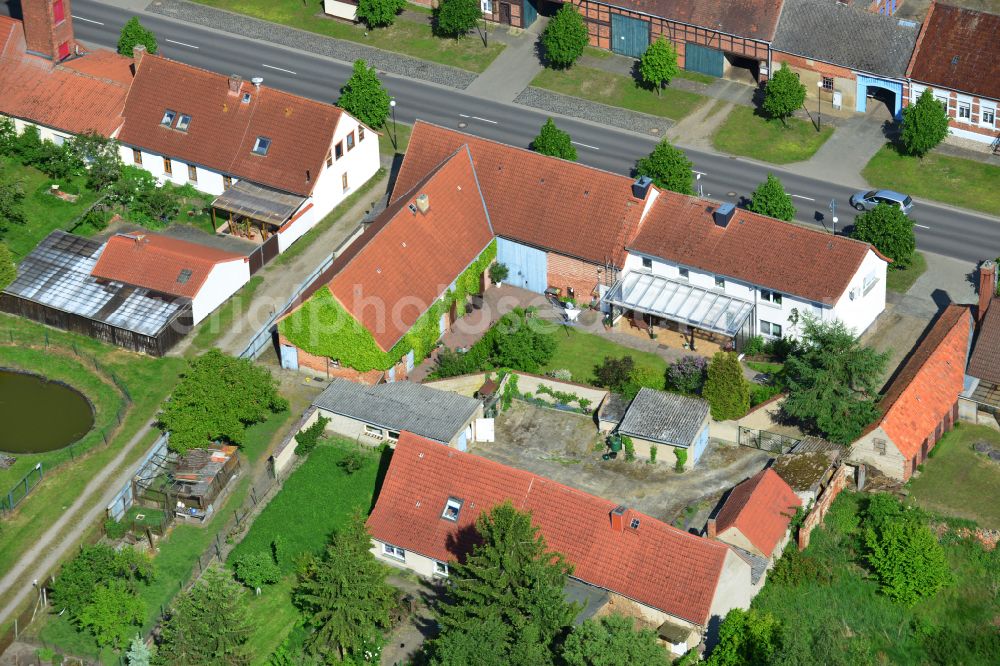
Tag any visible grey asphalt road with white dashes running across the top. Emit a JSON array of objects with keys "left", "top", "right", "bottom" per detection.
[{"left": 9, "top": 0, "right": 1000, "bottom": 261}]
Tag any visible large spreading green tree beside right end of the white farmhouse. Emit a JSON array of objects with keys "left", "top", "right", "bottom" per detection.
[{"left": 781, "top": 316, "right": 889, "bottom": 444}]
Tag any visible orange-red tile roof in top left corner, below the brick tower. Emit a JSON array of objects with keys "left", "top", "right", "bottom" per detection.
[{"left": 0, "top": 16, "right": 132, "bottom": 136}]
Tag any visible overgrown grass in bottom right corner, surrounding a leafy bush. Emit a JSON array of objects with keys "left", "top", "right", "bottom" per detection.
[{"left": 753, "top": 491, "right": 1000, "bottom": 665}]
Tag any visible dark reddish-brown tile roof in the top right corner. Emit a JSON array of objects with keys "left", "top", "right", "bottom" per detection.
[{"left": 907, "top": 3, "right": 1000, "bottom": 99}]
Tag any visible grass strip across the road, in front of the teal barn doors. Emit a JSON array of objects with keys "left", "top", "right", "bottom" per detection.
[{"left": 531, "top": 65, "right": 706, "bottom": 120}]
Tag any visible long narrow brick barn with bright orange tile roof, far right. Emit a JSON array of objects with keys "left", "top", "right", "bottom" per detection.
[{"left": 850, "top": 305, "right": 973, "bottom": 481}]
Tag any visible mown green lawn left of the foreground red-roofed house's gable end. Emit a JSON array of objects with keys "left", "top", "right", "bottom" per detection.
[{"left": 229, "top": 439, "right": 388, "bottom": 661}]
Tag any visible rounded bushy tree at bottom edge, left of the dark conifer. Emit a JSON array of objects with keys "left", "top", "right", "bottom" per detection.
[{"left": 156, "top": 567, "right": 253, "bottom": 666}]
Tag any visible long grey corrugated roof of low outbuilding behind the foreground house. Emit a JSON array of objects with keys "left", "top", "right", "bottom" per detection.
[{"left": 313, "top": 379, "right": 480, "bottom": 444}]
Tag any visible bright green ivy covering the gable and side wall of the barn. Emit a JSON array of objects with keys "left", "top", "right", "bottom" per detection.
[{"left": 278, "top": 240, "right": 497, "bottom": 372}]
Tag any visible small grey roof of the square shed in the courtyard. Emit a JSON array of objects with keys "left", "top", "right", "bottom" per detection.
[{"left": 618, "top": 388, "right": 708, "bottom": 447}]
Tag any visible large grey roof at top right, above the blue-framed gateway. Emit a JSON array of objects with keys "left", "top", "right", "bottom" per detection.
[{"left": 771, "top": 0, "right": 920, "bottom": 78}]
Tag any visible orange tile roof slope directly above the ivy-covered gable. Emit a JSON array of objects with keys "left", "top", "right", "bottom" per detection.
[{"left": 329, "top": 147, "right": 493, "bottom": 351}]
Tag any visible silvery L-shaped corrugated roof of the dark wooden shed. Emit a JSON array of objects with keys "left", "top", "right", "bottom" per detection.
[{"left": 5, "top": 231, "right": 188, "bottom": 336}]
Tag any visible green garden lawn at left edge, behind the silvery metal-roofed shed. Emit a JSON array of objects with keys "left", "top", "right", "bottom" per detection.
[{"left": 0, "top": 157, "right": 97, "bottom": 260}]
